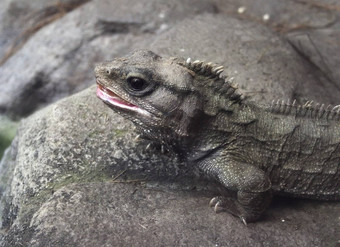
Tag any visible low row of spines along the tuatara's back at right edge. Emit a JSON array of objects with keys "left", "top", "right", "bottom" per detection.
[{"left": 270, "top": 100, "right": 340, "bottom": 120}]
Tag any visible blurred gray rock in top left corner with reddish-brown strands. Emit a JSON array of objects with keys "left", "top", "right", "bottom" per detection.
[{"left": 0, "top": 0, "right": 89, "bottom": 65}]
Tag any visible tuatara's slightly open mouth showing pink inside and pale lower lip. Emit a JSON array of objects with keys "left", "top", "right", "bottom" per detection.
[{"left": 97, "top": 81, "right": 150, "bottom": 115}]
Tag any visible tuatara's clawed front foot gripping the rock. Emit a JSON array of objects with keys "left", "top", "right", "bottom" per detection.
[{"left": 209, "top": 196, "right": 247, "bottom": 225}]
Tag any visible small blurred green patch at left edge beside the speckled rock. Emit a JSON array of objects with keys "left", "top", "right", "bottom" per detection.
[{"left": 0, "top": 115, "right": 18, "bottom": 159}]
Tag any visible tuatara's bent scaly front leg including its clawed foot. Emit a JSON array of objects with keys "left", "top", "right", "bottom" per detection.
[{"left": 199, "top": 153, "right": 272, "bottom": 224}]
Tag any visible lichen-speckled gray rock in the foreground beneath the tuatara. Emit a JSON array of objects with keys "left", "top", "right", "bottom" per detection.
[{"left": 0, "top": 87, "right": 340, "bottom": 247}]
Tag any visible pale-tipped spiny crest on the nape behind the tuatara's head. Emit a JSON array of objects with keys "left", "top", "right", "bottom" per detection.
[{"left": 178, "top": 58, "right": 243, "bottom": 101}]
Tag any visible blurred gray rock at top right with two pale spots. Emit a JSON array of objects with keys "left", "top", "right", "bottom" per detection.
[{"left": 213, "top": 0, "right": 338, "bottom": 30}]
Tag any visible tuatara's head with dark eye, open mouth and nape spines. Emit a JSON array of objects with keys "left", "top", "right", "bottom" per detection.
[{"left": 95, "top": 51, "right": 239, "bottom": 148}]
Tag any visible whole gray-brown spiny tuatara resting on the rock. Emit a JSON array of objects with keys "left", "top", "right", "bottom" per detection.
[{"left": 95, "top": 51, "right": 340, "bottom": 223}]
